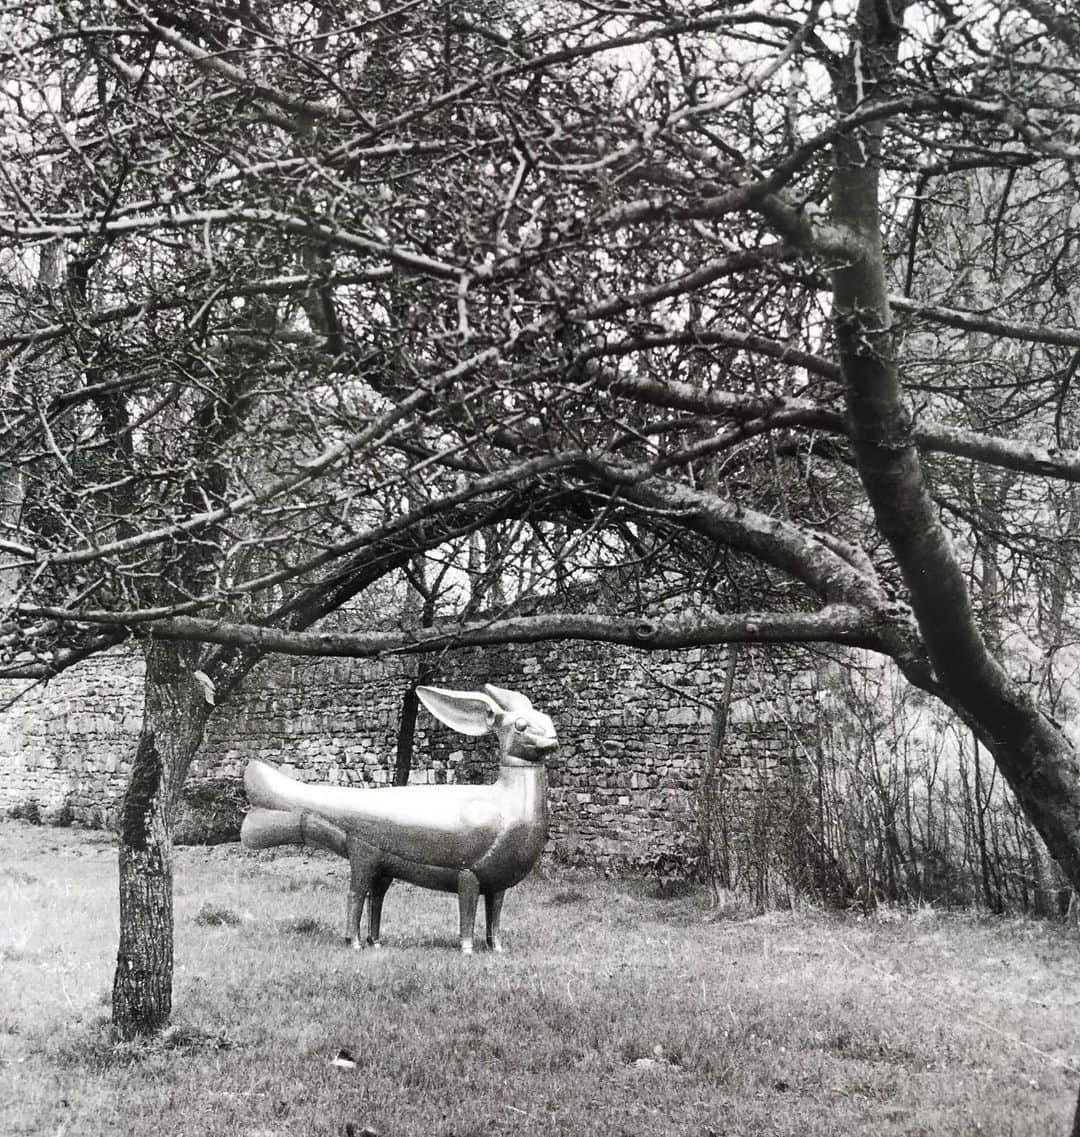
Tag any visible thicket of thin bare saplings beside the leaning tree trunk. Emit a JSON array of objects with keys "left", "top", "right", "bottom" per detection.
[{"left": 691, "top": 669, "right": 1078, "bottom": 920}]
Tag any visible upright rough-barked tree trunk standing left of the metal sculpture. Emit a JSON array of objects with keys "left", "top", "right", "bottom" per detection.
[{"left": 113, "top": 641, "right": 210, "bottom": 1039}]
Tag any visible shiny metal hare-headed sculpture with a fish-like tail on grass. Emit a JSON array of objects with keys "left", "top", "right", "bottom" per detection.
[{"left": 241, "top": 683, "right": 558, "bottom": 954}]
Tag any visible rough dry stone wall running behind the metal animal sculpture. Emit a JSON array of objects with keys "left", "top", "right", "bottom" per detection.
[{"left": 0, "top": 642, "right": 814, "bottom": 871}]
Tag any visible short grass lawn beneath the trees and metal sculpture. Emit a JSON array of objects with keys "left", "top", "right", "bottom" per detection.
[{"left": 0, "top": 822, "right": 1080, "bottom": 1137}]
